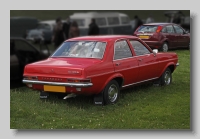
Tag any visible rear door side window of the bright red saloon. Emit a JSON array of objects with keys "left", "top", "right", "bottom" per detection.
[{"left": 114, "top": 40, "right": 133, "bottom": 60}]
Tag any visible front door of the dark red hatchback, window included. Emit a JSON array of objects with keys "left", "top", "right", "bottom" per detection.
[{"left": 174, "top": 25, "right": 189, "bottom": 47}]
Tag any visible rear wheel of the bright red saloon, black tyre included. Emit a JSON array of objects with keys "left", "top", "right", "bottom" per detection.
[{"left": 103, "top": 80, "right": 120, "bottom": 105}]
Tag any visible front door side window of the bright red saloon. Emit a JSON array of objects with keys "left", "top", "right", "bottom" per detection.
[{"left": 130, "top": 40, "right": 151, "bottom": 56}]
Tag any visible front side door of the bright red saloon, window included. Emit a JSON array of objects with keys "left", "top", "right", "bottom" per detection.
[{"left": 130, "top": 40, "right": 159, "bottom": 82}]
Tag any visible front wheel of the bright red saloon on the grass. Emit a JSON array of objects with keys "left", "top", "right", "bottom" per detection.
[{"left": 160, "top": 68, "right": 172, "bottom": 86}]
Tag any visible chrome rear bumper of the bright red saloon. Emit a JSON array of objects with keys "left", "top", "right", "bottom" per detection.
[{"left": 22, "top": 79, "right": 93, "bottom": 87}]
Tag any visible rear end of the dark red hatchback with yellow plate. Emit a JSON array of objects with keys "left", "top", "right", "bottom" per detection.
[{"left": 133, "top": 24, "right": 164, "bottom": 49}]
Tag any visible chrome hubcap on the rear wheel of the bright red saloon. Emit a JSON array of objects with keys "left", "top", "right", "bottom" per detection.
[{"left": 108, "top": 84, "right": 118, "bottom": 102}]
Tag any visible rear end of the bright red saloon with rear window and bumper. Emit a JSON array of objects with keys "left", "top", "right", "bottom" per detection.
[{"left": 23, "top": 41, "right": 106, "bottom": 94}]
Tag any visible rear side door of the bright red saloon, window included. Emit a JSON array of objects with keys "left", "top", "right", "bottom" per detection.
[{"left": 113, "top": 40, "right": 138, "bottom": 86}]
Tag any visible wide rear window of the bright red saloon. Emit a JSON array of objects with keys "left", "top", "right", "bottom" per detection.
[{"left": 51, "top": 41, "right": 106, "bottom": 59}]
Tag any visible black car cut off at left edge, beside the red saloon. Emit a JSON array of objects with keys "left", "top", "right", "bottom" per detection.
[{"left": 10, "top": 37, "right": 49, "bottom": 80}]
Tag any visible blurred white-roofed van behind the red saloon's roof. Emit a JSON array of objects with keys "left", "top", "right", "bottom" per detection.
[{"left": 70, "top": 12, "right": 132, "bottom": 36}]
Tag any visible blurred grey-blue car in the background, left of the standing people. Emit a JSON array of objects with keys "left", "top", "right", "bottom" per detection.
[{"left": 26, "top": 20, "right": 56, "bottom": 44}]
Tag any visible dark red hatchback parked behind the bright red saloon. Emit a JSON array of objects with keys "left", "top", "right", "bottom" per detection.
[{"left": 133, "top": 23, "right": 190, "bottom": 52}]
